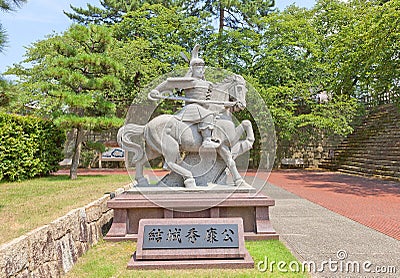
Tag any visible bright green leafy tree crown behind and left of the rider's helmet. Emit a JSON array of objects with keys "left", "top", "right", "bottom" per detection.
[{"left": 106, "top": 4, "right": 203, "bottom": 116}]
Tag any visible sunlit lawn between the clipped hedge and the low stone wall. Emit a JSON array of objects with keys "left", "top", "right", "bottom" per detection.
[{"left": 0, "top": 175, "right": 131, "bottom": 244}]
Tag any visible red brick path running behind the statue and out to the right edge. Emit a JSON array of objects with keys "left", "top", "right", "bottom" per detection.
[{"left": 57, "top": 169, "right": 400, "bottom": 240}]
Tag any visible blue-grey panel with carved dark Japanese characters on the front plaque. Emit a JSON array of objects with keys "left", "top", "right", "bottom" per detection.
[{"left": 143, "top": 224, "right": 239, "bottom": 249}]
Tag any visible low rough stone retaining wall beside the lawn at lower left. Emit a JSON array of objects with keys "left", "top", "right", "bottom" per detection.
[{"left": 0, "top": 185, "right": 129, "bottom": 278}]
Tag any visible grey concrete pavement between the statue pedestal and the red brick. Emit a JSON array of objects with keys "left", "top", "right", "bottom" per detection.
[{"left": 264, "top": 173, "right": 400, "bottom": 277}]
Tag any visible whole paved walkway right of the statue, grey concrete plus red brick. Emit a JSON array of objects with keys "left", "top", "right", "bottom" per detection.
[{"left": 258, "top": 171, "right": 400, "bottom": 277}]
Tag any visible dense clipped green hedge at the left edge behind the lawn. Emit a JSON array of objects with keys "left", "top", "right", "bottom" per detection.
[{"left": 0, "top": 113, "right": 65, "bottom": 181}]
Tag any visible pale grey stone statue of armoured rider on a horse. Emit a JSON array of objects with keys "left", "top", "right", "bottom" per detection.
[{"left": 118, "top": 45, "right": 254, "bottom": 188}]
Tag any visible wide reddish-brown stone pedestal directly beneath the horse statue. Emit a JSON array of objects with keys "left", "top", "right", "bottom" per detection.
[{"left": 105, "top": 188, "right": 279, "bottom": 241}]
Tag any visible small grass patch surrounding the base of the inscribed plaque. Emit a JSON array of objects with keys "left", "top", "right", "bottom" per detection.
[{"left": 66, "top": 240, "right": 309, "bottom": 278}]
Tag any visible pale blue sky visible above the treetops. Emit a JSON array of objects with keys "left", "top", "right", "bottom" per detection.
[{"left": 0, "top": 0, "right": 315, "bottom": 74}]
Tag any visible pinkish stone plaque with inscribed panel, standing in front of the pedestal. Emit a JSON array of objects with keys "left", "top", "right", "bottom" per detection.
[{"left": 128, "top": 217, "right": 254, "bottom": 269}]
